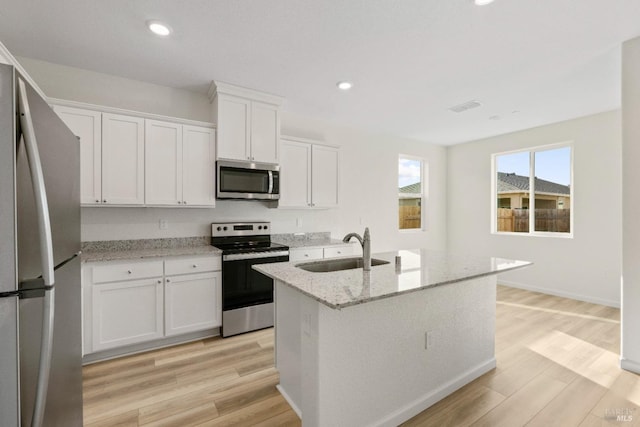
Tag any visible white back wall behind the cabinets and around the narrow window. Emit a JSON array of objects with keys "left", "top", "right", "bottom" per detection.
[{"left": 20, "top": 58, "right": 447, "bottom": 251}]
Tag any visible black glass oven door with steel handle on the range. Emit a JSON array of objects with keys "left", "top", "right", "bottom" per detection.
[{"left": 222, "top": 251, "right": 289, "bottom": 311}]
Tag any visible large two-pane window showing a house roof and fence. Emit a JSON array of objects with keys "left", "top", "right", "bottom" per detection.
[{"left": 492, "top": 144, "right": 573, "bottom": 236}]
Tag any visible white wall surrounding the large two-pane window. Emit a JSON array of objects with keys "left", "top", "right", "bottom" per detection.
[{"left": 448, "top": 111, "right": 620, "bottom": 306}]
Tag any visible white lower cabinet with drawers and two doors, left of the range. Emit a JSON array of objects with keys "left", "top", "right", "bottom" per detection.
[{"left": 82, "top": 255, "right": 222, "bottom": 354}]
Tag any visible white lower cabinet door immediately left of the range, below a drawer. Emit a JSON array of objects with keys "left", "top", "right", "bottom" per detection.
[{"left": 165, "top": 272, "right": 222, "bottom": 336}]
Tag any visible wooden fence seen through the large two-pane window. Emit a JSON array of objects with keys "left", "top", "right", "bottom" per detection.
[{"left": 498, "top": 209, "right": 571, "bottom": 233}]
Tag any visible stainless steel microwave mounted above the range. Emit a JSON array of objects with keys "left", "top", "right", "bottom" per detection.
[{"left": 216, "top": 160, "right": 280, "bottom": 200}]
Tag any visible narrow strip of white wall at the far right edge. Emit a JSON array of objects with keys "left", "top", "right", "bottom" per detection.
[{"left": 620, "top": 38, "right": 640, "bottom": 373}]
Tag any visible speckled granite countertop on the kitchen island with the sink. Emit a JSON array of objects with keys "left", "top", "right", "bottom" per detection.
[{"left": 253, "top": 249, "right": 531, "bottom": 309}]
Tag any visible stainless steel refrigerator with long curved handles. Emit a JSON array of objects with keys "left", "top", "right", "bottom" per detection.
[{"left": 0, "top": 64, "right": 82, "bottom": 427}]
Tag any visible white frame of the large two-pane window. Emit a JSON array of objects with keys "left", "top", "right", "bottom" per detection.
[{"left": 490, "top": 141, "right": 575, "bottom": 239}]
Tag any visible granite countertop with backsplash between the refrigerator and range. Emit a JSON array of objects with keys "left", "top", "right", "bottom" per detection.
[{"left": 81, "top": 236, "right": 222, "bottom": 263}]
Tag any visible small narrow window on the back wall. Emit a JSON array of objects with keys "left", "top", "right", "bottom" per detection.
[{"left": 398, "top": 156, "right": 424, "bottom": 230}]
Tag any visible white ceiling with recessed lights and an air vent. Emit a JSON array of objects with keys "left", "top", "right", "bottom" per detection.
[{"left": 0, "top": 0, "right": 640, "bottom": 145}]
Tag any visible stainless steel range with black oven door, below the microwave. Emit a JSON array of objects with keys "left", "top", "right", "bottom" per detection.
[{"left": 211, "top": 222, "right": 289, "bottom": 337}]
